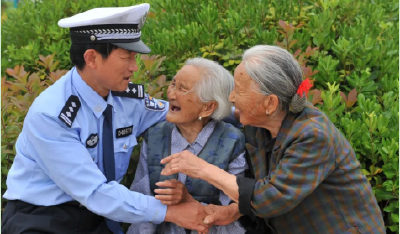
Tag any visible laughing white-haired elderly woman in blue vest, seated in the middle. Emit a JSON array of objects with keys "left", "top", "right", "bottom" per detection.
[{"left": 128, "top": 58, "right": 247, "bottom": 234}]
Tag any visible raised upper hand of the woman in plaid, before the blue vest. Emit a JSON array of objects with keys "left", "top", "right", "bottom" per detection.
[{"left": 161, "top": 150, "right": 208, "bottom": 179}]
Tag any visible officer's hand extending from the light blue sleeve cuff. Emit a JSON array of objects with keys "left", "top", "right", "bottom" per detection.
[{"left": 164, "top": 201, "right": 208, "bottom": 233}]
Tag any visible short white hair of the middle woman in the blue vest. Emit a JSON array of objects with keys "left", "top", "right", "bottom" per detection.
[{"left": 185, "top": 58, "right": 234, "bottom": 120}]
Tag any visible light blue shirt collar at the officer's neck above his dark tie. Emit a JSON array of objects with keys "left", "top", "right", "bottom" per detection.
[{"left": 72, "top": 67, "right": 115, "bottom": 118}]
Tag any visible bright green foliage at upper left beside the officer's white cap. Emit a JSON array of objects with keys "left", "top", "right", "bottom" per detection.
[{"left": 1, "top": 0, "right": 148, "bottom": 75}]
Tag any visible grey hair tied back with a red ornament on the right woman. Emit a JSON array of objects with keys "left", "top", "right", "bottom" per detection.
[{"left": 243, "top": 45, "right": 305, "bottom": 111}]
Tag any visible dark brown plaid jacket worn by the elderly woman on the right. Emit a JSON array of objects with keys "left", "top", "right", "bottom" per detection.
[{"left": 238, "top": 103, "right": 385, "bottom": 234}]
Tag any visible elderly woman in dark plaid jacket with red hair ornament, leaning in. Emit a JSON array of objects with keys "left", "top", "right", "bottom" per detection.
[{"left": 161, "top": 45, "right": 385, "bottom": 234}]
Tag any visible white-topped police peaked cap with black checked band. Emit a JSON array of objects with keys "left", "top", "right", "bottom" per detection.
[{"left": 58, "top": 3, "right": 151, "bottom": 54}]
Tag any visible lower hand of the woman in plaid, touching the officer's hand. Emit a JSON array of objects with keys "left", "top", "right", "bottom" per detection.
[{"left": 203, "top": 203, "right": 241, "bottom": 226}]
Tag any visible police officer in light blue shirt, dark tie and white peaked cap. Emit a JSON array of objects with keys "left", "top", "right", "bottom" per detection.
[{"left": 2, "top": 4, "right": 207, "bottom": 234}]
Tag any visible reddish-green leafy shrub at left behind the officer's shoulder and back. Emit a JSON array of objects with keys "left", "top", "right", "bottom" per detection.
[{"left": 1, "top": 55, "right": 67, "bottom": 207}]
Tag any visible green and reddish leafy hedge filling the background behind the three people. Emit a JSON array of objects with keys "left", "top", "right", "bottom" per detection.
[{"left": 1, "top": 0, "right": 399, "bottom": 233}]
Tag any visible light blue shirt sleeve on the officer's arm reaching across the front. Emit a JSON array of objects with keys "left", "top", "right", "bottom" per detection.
[{"left": 25, "top": 113, "right": 167, "bottom": 223}]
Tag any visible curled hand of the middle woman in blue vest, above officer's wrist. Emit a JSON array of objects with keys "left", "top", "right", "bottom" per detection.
[{"left": 154, "top": 179, "right": 193, "bottom": 205}]
